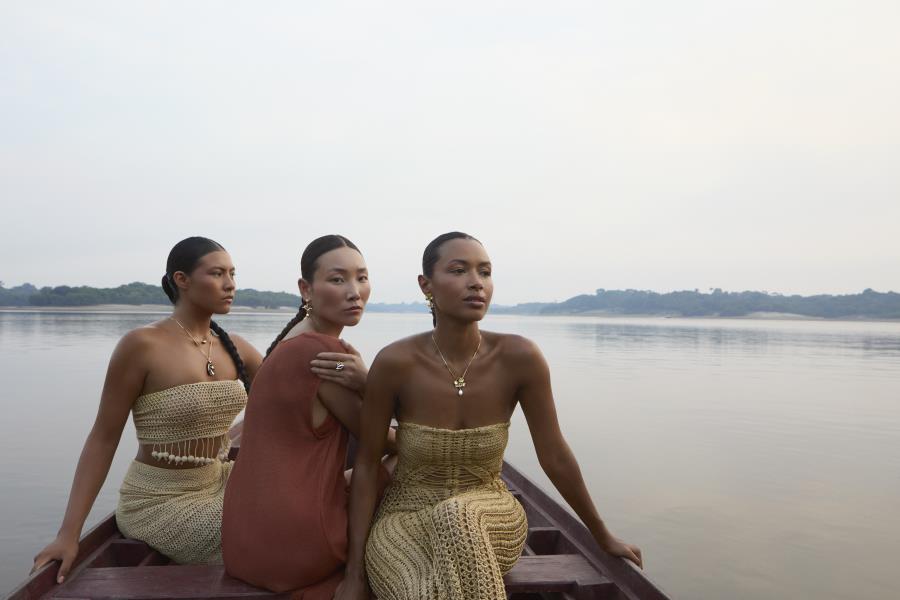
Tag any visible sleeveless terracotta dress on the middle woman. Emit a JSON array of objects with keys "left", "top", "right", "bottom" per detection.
[{"left": 222, "top": 333, "right": 349, "bottom": 600}]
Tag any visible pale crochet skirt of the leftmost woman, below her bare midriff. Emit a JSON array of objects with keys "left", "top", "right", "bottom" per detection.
[{"left": 116, "top": 461, "right": 233, "bottom": 564}]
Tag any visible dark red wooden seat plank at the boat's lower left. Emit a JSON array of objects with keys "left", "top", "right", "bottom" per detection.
[{"left": 48, "top": 565, "right": 289, "bottom": 600}]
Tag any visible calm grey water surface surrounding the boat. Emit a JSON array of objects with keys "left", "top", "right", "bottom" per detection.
[{"left": 0, "top": 313, "right": 900, "bottom": 599}]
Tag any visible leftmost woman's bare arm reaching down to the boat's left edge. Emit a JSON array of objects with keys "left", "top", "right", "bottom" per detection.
[{"left": 32, "top": 332, "right": 146, "bottom": 583}]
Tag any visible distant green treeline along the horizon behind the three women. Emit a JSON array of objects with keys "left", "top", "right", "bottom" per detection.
[{"left": 0, "top": 283, "right": 900, "bottom": 319}]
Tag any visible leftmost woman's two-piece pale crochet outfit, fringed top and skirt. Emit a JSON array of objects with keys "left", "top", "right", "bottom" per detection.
[{"left": 116, "top": 380, "right": 247, "bottom": 564}]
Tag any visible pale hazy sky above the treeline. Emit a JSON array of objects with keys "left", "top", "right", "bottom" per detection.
[{"left": 0, "top": 0, "right": 900, "bottom": 304}]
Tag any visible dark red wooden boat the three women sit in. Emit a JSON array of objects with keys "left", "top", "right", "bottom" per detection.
[{"left": 8, "top": 423, "right": 668, "bottom": 600}]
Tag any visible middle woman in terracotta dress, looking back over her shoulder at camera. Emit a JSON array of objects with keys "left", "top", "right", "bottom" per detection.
[{"left": 222, "top": 235, "right": 393, "bottom": 600}]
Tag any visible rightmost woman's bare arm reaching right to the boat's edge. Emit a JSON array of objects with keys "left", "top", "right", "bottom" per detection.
[{"left": 510, "top": 338, "right": 643, "bottom": 567}]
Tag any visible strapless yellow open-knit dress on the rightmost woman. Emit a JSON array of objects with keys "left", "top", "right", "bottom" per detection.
[{"left": 366, "top": 422, "right": 528, "bottom": 600}]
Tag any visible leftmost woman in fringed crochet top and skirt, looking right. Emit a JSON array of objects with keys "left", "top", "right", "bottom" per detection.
[{"left": 34, "top": 237, "right": 262, "bottom": 583}]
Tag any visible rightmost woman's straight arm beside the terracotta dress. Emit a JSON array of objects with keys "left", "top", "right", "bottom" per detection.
[{"left": 334, "top": 347, "right": 402, "bottom": 600}]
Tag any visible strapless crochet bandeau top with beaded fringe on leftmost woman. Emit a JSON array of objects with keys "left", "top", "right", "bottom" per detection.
[{"left": 131, "top": 379, "right": 247, "bottom": 465}]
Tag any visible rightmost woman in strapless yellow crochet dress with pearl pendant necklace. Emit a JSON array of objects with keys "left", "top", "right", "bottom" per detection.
[{"left": 335, "top": 232, "right": 641, "bottom": 600}]
